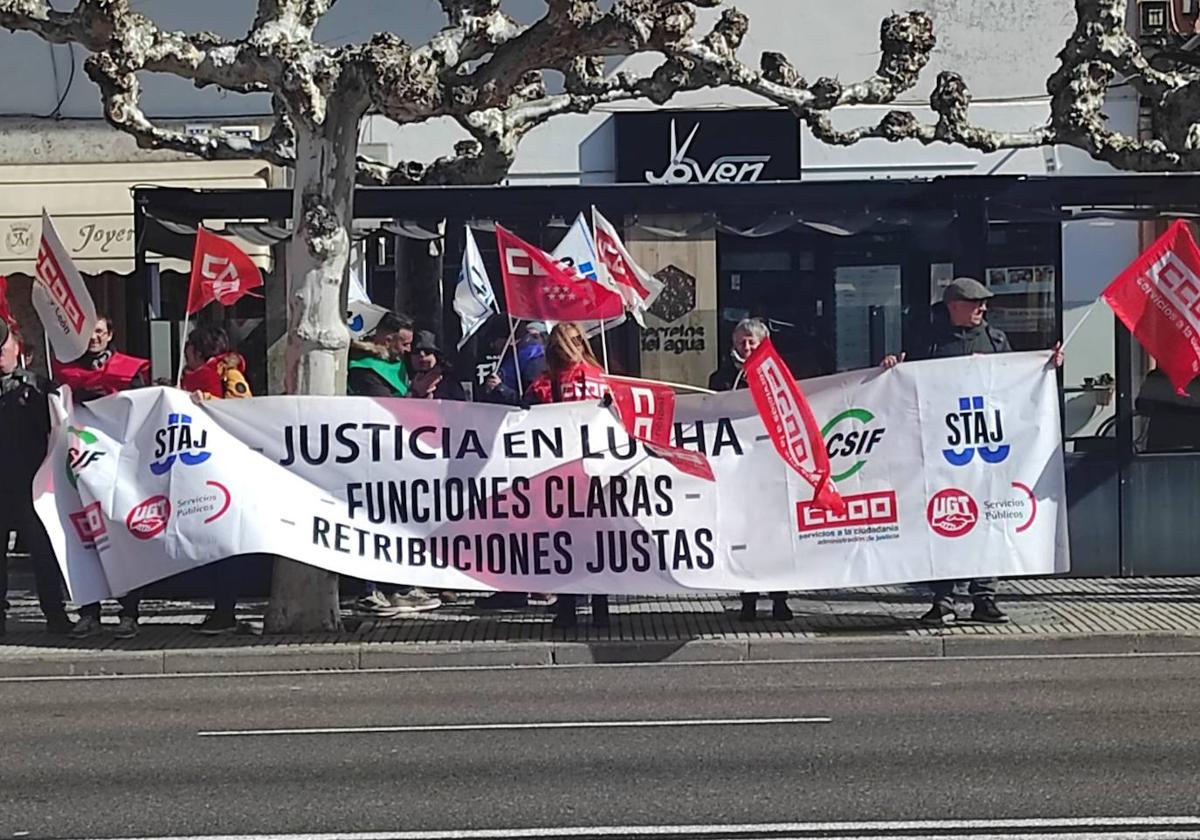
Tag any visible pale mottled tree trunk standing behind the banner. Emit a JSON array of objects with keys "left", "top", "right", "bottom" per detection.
[{"left": 264, "top": 102, "right": 360, "bottom": 634}]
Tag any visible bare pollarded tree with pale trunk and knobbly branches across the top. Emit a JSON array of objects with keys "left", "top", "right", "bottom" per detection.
[{"left": 0, "top": 0, "right": 1185, "bottom": 631}]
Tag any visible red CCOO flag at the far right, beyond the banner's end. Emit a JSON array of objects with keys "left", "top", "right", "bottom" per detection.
[{"left": 1100, "top": 220, "right": 1200, "bottom": 396}]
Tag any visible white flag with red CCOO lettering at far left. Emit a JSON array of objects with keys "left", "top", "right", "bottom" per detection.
[{"left": 31, "top": 208, "right": 96, "bottom": 361}]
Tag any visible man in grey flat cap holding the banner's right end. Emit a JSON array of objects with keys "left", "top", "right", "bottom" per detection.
[{"left": 882, "top": 277, "right": 1063, "bottom": 628}]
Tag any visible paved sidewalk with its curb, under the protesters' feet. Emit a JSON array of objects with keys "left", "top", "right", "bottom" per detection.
[{"left": 0, "top": 574, "right": 1200, "bottom": 678}]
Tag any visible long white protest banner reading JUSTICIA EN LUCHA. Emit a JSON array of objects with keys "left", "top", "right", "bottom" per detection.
[{"left": 35, "top": 353, "right": 1068, "bottom": 602}]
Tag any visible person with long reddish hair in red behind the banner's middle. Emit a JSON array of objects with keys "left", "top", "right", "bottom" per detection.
[{"left": 526, "top": 322, "right": 608, "bottom": 628}]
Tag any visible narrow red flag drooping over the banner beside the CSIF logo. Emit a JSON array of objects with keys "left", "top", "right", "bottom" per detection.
[{"left": 744, "top": 338, "right": 846, "bottom": 514}]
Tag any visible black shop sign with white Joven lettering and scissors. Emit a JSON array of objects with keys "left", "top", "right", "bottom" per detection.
[{"left": 616, "top": 109, "right": 800, "bottom": 184}]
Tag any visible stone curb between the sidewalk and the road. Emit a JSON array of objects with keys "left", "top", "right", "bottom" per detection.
[{"left": 7, "top": 631, "right": 1200, "bottom": 679}]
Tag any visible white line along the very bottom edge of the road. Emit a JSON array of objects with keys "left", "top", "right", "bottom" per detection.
[{"left": 49, "top": 817, "right": 1200, "bottom": 840}]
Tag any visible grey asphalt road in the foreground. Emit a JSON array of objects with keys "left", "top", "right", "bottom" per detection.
[{"left": 0, "top": 656, "right": 1200, "bottom": 839}]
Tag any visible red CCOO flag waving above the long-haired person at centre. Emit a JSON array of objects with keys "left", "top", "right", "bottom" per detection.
[{"left": 496, "top": 224, "right": 625, "bottom": 320}]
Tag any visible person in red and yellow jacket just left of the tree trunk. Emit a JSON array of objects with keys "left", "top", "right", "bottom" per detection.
[{"left": 180, "top": 324, "right": 252, "bottom": 636}]
